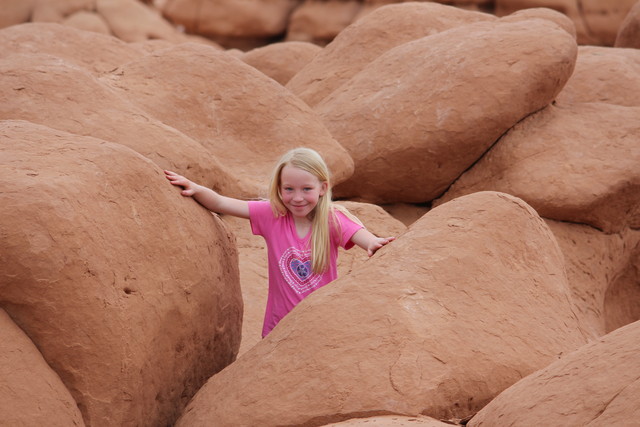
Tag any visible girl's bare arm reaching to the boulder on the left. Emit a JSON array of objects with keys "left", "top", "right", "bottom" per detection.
[{"left": 164, "top": 171, "right": 249, "bottom": 219}]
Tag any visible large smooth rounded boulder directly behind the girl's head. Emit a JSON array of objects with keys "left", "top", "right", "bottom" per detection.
[{"left": 105, "top": 43, "right": 353, "bottom": 198}]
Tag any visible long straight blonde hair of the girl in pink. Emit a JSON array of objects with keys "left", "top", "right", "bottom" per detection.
[{"left": 269, "top": 148, "right": 361, "bottom": 274}]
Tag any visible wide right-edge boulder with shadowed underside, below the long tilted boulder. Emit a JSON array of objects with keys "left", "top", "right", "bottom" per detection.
[{"left": 436, "top": 103, "right": 640, "bottom": 233}]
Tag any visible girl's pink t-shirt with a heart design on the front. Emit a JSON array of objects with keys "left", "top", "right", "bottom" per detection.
[{"left": 249, "top": 201, "right": 362, "bottom": 338}]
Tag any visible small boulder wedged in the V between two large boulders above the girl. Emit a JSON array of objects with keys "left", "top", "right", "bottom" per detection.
[{"left": 239, "top": 41, "right": 322, "bottom": 86}]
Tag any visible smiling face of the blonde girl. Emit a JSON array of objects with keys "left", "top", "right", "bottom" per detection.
[{"left": 280, "top": 165, "right": 327, "bottom": 218}]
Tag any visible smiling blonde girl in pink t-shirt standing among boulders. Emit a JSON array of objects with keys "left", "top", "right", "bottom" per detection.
[{"left": 165, "top": 148, "right": 395, "bottom": 338}]
